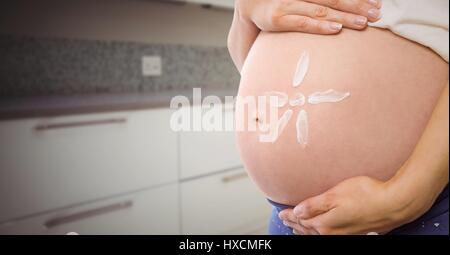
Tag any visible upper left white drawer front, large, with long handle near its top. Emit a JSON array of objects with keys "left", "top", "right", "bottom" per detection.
[{"left": 0, "top": 109, "right": 177, "bottom": 222}]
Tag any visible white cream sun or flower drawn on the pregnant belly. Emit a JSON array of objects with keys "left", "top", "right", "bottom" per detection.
[{"left": 260, "top": 52, "right": 350, "bottom": 148}]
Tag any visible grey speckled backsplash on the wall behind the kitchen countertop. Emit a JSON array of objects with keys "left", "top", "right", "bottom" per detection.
[{"left": 0, "top": 35, "right": 239, "bottom": 98}]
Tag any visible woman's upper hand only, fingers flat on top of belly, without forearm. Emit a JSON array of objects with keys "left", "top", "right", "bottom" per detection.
[{"left": 236, "top": 0, "right": 381, "bottom": 34}]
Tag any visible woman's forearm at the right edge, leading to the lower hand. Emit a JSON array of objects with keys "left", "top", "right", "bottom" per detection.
[{"left": 388, "top": 85, "right": 449, "bottom": 222}]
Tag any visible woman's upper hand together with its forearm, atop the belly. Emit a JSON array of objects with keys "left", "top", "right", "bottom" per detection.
[{"left": 228, "top": 0, "right": 381, "bottom": 71}]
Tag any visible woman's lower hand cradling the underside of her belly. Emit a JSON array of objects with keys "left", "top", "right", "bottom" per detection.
[{"left": 279, "top": 177, "right": 405, "bottom": 235}]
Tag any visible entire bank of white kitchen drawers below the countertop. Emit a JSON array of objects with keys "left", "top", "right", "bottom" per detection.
[{"left": 0, "top": 106, "right": 270, "bottom": 234}]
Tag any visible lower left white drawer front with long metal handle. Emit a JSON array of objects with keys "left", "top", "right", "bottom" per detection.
[{"left": 0, "top": 184, "right": 179, "bottom": 235}]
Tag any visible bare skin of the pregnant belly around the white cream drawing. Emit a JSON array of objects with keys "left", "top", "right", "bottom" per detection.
[{"left": 237, "top": 28, "right": 448, "bottom": 205}]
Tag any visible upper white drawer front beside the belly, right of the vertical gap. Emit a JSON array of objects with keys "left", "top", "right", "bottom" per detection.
[{"left": 180, "top": 106, "right": 242, "bottom": 178}]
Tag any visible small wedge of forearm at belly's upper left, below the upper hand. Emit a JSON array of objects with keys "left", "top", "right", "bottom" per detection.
[{"left": 228, "top": 2, "right": 260, "bottom": 72}]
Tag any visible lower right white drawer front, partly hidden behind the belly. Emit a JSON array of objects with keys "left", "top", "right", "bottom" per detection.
[{"left": 181, "top": 169, "right": 271, "bottom": 234}]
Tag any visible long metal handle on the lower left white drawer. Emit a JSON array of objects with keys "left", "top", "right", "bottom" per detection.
[{"left": 44, "top": 200, "right": 133, "bottom": 228}]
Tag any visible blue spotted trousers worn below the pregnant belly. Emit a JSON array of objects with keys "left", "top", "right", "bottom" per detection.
[{"left": 269, "top": 186, "right": 449, "bottom": 235}]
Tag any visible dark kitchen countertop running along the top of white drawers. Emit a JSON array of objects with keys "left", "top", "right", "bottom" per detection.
[{"left": 0, "top": 89, "right": 237, "bottom": 120}]
